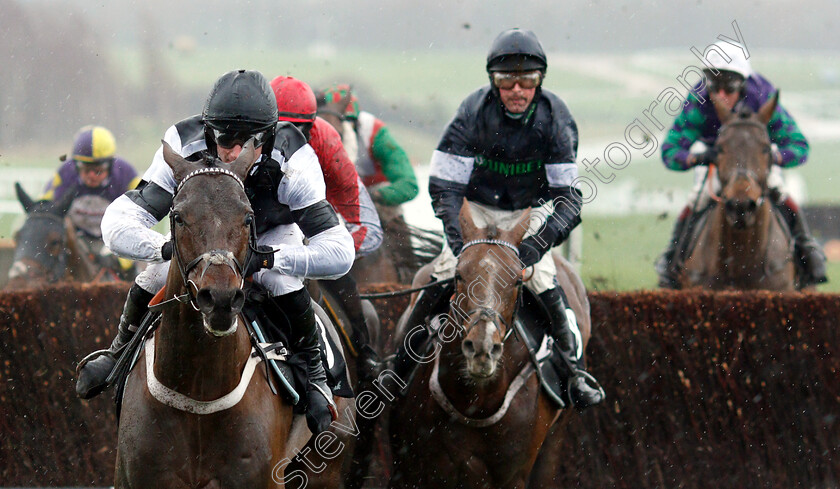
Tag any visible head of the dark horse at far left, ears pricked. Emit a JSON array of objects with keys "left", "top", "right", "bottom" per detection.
[{"left": 6, "top": 183, "right": 75, "bottom": 289}]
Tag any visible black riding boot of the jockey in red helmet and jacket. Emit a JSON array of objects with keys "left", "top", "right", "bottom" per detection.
[{"left": 320, "top": 273, "right": 381, "bottom": 382}]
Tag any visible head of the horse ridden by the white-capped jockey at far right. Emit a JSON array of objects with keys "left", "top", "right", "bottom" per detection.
[{"left": 713, "top": 92, "right": 779, "bottom": 229}]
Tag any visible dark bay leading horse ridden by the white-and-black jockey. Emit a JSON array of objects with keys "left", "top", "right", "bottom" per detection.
[{"left": 114, "top": 142, "right": 292, "bottom": 488}]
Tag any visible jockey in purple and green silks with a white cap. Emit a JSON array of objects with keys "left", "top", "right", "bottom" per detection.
[{"left": 656, "top": 41, "right": 827, "bottom": 288}]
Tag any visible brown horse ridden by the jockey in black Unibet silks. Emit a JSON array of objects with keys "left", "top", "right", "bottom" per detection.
[{"left": 390, "top": 204, "right": 591, "bottom": 489}]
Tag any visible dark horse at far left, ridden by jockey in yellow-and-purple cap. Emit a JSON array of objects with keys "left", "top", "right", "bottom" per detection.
[{"left": 5, "top": 183, "right": 99, "bottom": 290}]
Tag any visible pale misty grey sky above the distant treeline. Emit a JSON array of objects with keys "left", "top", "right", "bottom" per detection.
[{"left": 44, "top": 0, "right": 840, "bottom": 51}]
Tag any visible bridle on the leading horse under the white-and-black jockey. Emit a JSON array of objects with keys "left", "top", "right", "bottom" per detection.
[{"left": 169, "top": 167, "right": 256, "bottom": 311}]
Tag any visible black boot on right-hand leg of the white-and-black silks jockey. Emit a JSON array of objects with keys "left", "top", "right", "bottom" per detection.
[{"left": 272, "top": 287, "right": 338, "bottom": 435}]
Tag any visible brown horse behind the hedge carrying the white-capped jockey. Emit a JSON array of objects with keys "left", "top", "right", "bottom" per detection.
[{"left": 680, "top": 93, "right": 796, "bottom": 290}]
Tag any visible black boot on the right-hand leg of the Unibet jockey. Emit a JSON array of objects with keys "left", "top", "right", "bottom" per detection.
[{"left": 540, "top": 287, "right": 604, "bottom": 409}]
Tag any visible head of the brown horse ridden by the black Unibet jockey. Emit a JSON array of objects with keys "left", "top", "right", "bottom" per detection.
[{"left": 452, "top": 201, "right": 530, "bottom": 380}]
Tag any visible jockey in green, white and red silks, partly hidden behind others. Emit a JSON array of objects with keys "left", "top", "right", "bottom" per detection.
[{"left": 323, "top": 84, "right": 418, "bottom": 206}]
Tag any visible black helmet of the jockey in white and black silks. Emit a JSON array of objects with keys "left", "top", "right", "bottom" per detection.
[{"left": 201, "top": 70, "right": 277, "bottom": 157}]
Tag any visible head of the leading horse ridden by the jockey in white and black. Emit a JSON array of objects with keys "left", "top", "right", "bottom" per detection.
[{"left": 163, "top": 141, "right": 256, "bottom": 336}]
